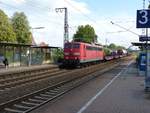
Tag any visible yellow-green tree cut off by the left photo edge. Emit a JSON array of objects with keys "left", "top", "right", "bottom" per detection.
[{"left": 0, "top": 10, "right": 16, "bottom": 42}]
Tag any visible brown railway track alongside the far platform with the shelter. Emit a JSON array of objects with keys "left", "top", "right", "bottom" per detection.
[{"left": 0, "top": 68, "right": 71, "bottom": 91}]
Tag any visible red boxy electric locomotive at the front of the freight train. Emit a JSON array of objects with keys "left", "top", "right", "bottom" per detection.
[{"left": 64, "top": 42, "right": 104, "bottom": 66}]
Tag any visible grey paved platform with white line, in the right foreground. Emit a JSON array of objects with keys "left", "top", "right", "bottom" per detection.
[{"left": 31, "top": 61, "right": 150, "bottom": 113}]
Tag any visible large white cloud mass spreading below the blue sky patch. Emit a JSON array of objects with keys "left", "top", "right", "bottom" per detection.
[{"left": 0, "top": 0, "right": 139, "bottom": 47}]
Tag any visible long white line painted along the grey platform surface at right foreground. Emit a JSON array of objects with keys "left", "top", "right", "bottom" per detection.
[{"left": 77, "top": 60, "right": 133, "bottom": 113}]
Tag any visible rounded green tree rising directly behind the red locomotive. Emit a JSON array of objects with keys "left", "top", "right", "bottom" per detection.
[{"left": 73, "top": 25, "right": 97, "bottom": 43}]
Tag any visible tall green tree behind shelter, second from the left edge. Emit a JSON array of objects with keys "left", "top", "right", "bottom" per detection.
[{"left": 11, "top": 12, "right": 32, "bottom": 44}]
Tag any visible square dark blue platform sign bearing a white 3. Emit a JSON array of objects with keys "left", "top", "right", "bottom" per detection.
[{"left": 136, "top": 9, "right": 150, "bottom": 28}]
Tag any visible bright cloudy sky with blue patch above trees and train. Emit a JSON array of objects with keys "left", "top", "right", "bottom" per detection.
[{"left": 0, "top": 0, "right": 148, "bottom": 48}]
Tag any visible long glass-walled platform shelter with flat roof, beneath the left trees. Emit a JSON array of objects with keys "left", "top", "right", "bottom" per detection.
[{"left": 0, "top": 42, "right": 59, "bottom": 67}]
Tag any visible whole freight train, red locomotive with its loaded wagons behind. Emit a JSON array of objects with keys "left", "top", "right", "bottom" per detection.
[{"left": 63, "top": 42, "right": 127, "bottom": 66}]
